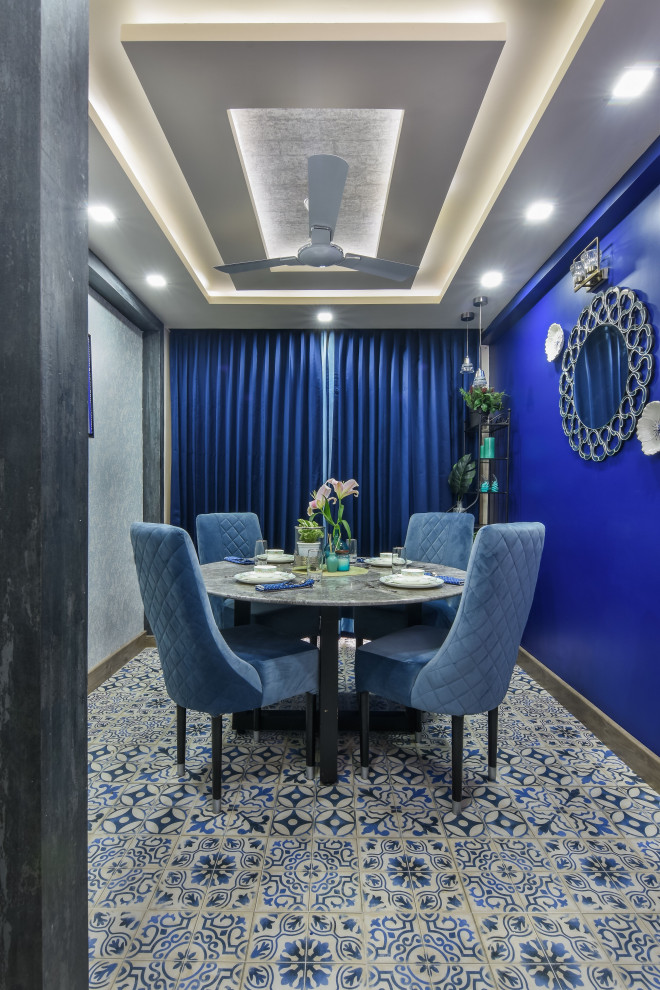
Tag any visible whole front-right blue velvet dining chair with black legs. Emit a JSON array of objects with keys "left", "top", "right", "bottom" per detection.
[{"left": 355, "top": 523, "right": 545, "bottom": 814}]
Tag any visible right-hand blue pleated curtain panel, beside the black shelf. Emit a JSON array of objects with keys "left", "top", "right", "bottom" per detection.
[{"left": 330, "top": 330, "right": 464, "bottom": 554}]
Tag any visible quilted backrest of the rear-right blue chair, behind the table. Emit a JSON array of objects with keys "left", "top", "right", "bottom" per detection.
[{"left": 406, "top": 512, "right": 474, "bottom": 571}]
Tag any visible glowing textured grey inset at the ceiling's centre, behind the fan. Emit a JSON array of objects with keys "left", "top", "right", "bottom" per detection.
[{"left": 229, "top": 107, "right": 403, "bottom": 260}]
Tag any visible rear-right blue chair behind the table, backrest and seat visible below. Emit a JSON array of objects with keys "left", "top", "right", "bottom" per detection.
[{"left": 353, "top": 512, "right": 474, "bottom": 646}]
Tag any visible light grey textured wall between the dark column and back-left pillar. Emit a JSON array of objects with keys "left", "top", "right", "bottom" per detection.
[{"left": 88, "top": 291, "right": 144, "bottom": 668}]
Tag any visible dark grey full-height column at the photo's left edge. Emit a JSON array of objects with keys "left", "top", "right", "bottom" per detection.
[{"left": 0, "top": 0, "right": 88, "bottom": 990}]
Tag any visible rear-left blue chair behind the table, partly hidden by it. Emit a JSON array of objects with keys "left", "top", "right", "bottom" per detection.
[{"left": 197, "top": 512, "right": 319, "bottom": 640}]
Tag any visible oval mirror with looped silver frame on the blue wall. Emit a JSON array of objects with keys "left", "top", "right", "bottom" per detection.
[{"left": 559, "top": 287, "right": 653, "bottom": 461}]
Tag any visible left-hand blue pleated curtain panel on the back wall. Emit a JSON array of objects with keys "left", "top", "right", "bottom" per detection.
[{"left": 170, "top": 330, "right": 323, "bottom": 549}]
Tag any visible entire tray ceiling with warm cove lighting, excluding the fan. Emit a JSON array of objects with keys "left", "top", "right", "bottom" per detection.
[{"left": 89, "top": 0, "right": 660, "bottom": 328}]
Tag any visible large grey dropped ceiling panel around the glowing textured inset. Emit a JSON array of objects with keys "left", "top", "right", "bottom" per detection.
[{"left": 123, "top": 39, "right": 504, "bottom": 295}]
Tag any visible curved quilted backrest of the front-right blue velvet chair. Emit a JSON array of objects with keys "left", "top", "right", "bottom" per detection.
[{"left": 411, "top": 523, "right": 545, "bottom": 715}]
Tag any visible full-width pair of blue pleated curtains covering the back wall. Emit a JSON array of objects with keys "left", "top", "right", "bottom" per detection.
[{"left": 170, "top": 330, "right": 464, "bottom": 554}]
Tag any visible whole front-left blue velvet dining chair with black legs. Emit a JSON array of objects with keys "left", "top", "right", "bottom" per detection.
[{"left": 131, "top": 523, "right": 319, "bottom": 813}]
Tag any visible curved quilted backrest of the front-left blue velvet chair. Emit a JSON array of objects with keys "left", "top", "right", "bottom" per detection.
[{"left": 131, "top": 523, "right": 262, "bottom": 716}]
